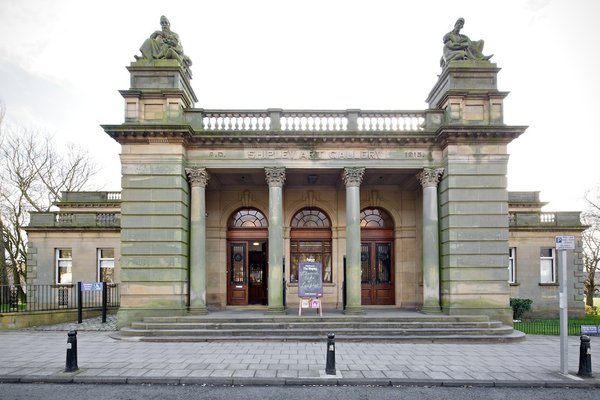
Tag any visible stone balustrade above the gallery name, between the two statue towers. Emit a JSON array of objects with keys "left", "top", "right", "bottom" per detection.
[{"left": 202, "top": 109, "right": 425, "bottom": 132}]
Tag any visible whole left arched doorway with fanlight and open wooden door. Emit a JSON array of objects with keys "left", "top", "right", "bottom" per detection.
[{"left": 227, "top": 208, "right": 269, "bottom": 305}]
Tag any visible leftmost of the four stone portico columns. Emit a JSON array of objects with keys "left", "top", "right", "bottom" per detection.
[{"left": 185, "top": 168, "right": 209, "bottom": 314}]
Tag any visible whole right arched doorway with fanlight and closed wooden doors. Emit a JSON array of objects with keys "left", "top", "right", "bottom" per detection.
[{"left": 360, "top": 208, "right": 396, "bottom": 305}]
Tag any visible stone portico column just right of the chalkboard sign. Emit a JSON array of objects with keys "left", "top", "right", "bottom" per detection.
[{"left": 342, "top": 168, "right": 365, "bottom": 314}]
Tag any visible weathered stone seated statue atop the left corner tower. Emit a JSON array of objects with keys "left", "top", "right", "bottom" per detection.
[{"left": 135, "top": 15, "right": 192, "bottom": 67}]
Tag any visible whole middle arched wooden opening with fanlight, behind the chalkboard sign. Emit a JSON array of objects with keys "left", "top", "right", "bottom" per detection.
[{"left": 290, "top": 207, "right": 333, "bottom": 283}]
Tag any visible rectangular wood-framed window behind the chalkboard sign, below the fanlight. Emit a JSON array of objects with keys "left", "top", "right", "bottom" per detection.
[{"left": 290, "top": 240, "right": 332, "bottom": 283}]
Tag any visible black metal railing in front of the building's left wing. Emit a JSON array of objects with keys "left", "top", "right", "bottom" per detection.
[{"left": 0, "top": 283, "right": 121, "bottom": 313}]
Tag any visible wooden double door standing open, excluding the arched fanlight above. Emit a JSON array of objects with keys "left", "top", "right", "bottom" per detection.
[{"left": 227, "top": 239, "right": 269, "bottom": 305}]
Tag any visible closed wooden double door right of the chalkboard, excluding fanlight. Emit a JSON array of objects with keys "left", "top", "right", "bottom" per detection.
[{"left": 360, "top": 230, "right": 396, "bottom": 305}]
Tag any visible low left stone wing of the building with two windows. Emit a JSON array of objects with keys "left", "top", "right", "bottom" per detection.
[{"left": 26, "top": 192, "right": 121, "bottom": 286}]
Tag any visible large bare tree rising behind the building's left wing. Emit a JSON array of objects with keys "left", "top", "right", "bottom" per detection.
[{"left": 0, "top": 108, "right": 97, "bottom": 296}]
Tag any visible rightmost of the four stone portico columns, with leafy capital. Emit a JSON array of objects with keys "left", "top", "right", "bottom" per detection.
[{"left": 417, "top": 168, "right": 444, "bottom": 313}]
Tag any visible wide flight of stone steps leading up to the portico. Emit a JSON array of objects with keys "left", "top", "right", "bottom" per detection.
[{"left": 115, "top": 314, "right": 525, "bottom": 343}]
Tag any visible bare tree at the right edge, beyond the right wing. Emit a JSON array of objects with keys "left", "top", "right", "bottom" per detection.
[{"left": 582, "top": 186, "right": 600, "bottom": 306}]
